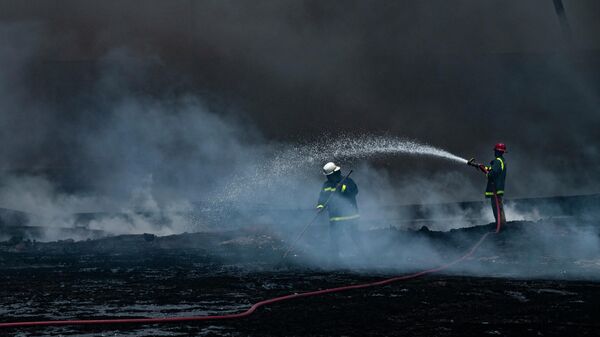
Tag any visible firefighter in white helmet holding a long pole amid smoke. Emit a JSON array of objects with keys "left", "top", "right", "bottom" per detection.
[{"left": 317, "top": 162, "right": 363, "bottom": 261}]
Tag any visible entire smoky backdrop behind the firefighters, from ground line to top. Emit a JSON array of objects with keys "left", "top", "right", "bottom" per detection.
[{"left": 0, "top": 0, "right": 600, "bottom": 234}]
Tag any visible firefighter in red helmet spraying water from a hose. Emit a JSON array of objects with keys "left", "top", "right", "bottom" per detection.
[{"left": 468, "top": 143, "right": 506, "bottom": 224}]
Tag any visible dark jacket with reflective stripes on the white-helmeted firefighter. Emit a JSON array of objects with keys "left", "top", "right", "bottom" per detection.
[{"left": 317, "top": 178, "right": 359, "bottom": 221}]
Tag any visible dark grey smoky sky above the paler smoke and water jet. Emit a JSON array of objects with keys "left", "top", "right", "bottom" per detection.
[{"left": 0, "top": 0, "right": 600, "bottom": 200}]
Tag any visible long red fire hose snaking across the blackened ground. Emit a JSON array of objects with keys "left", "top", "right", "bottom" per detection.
[{"left": 0, "top": 207, "right": 500, "bottom": 328}]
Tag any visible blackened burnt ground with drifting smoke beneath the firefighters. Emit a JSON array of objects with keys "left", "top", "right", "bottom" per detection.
[{"left": 0, "top": 219, "right": 600, "bottom": 336}]
